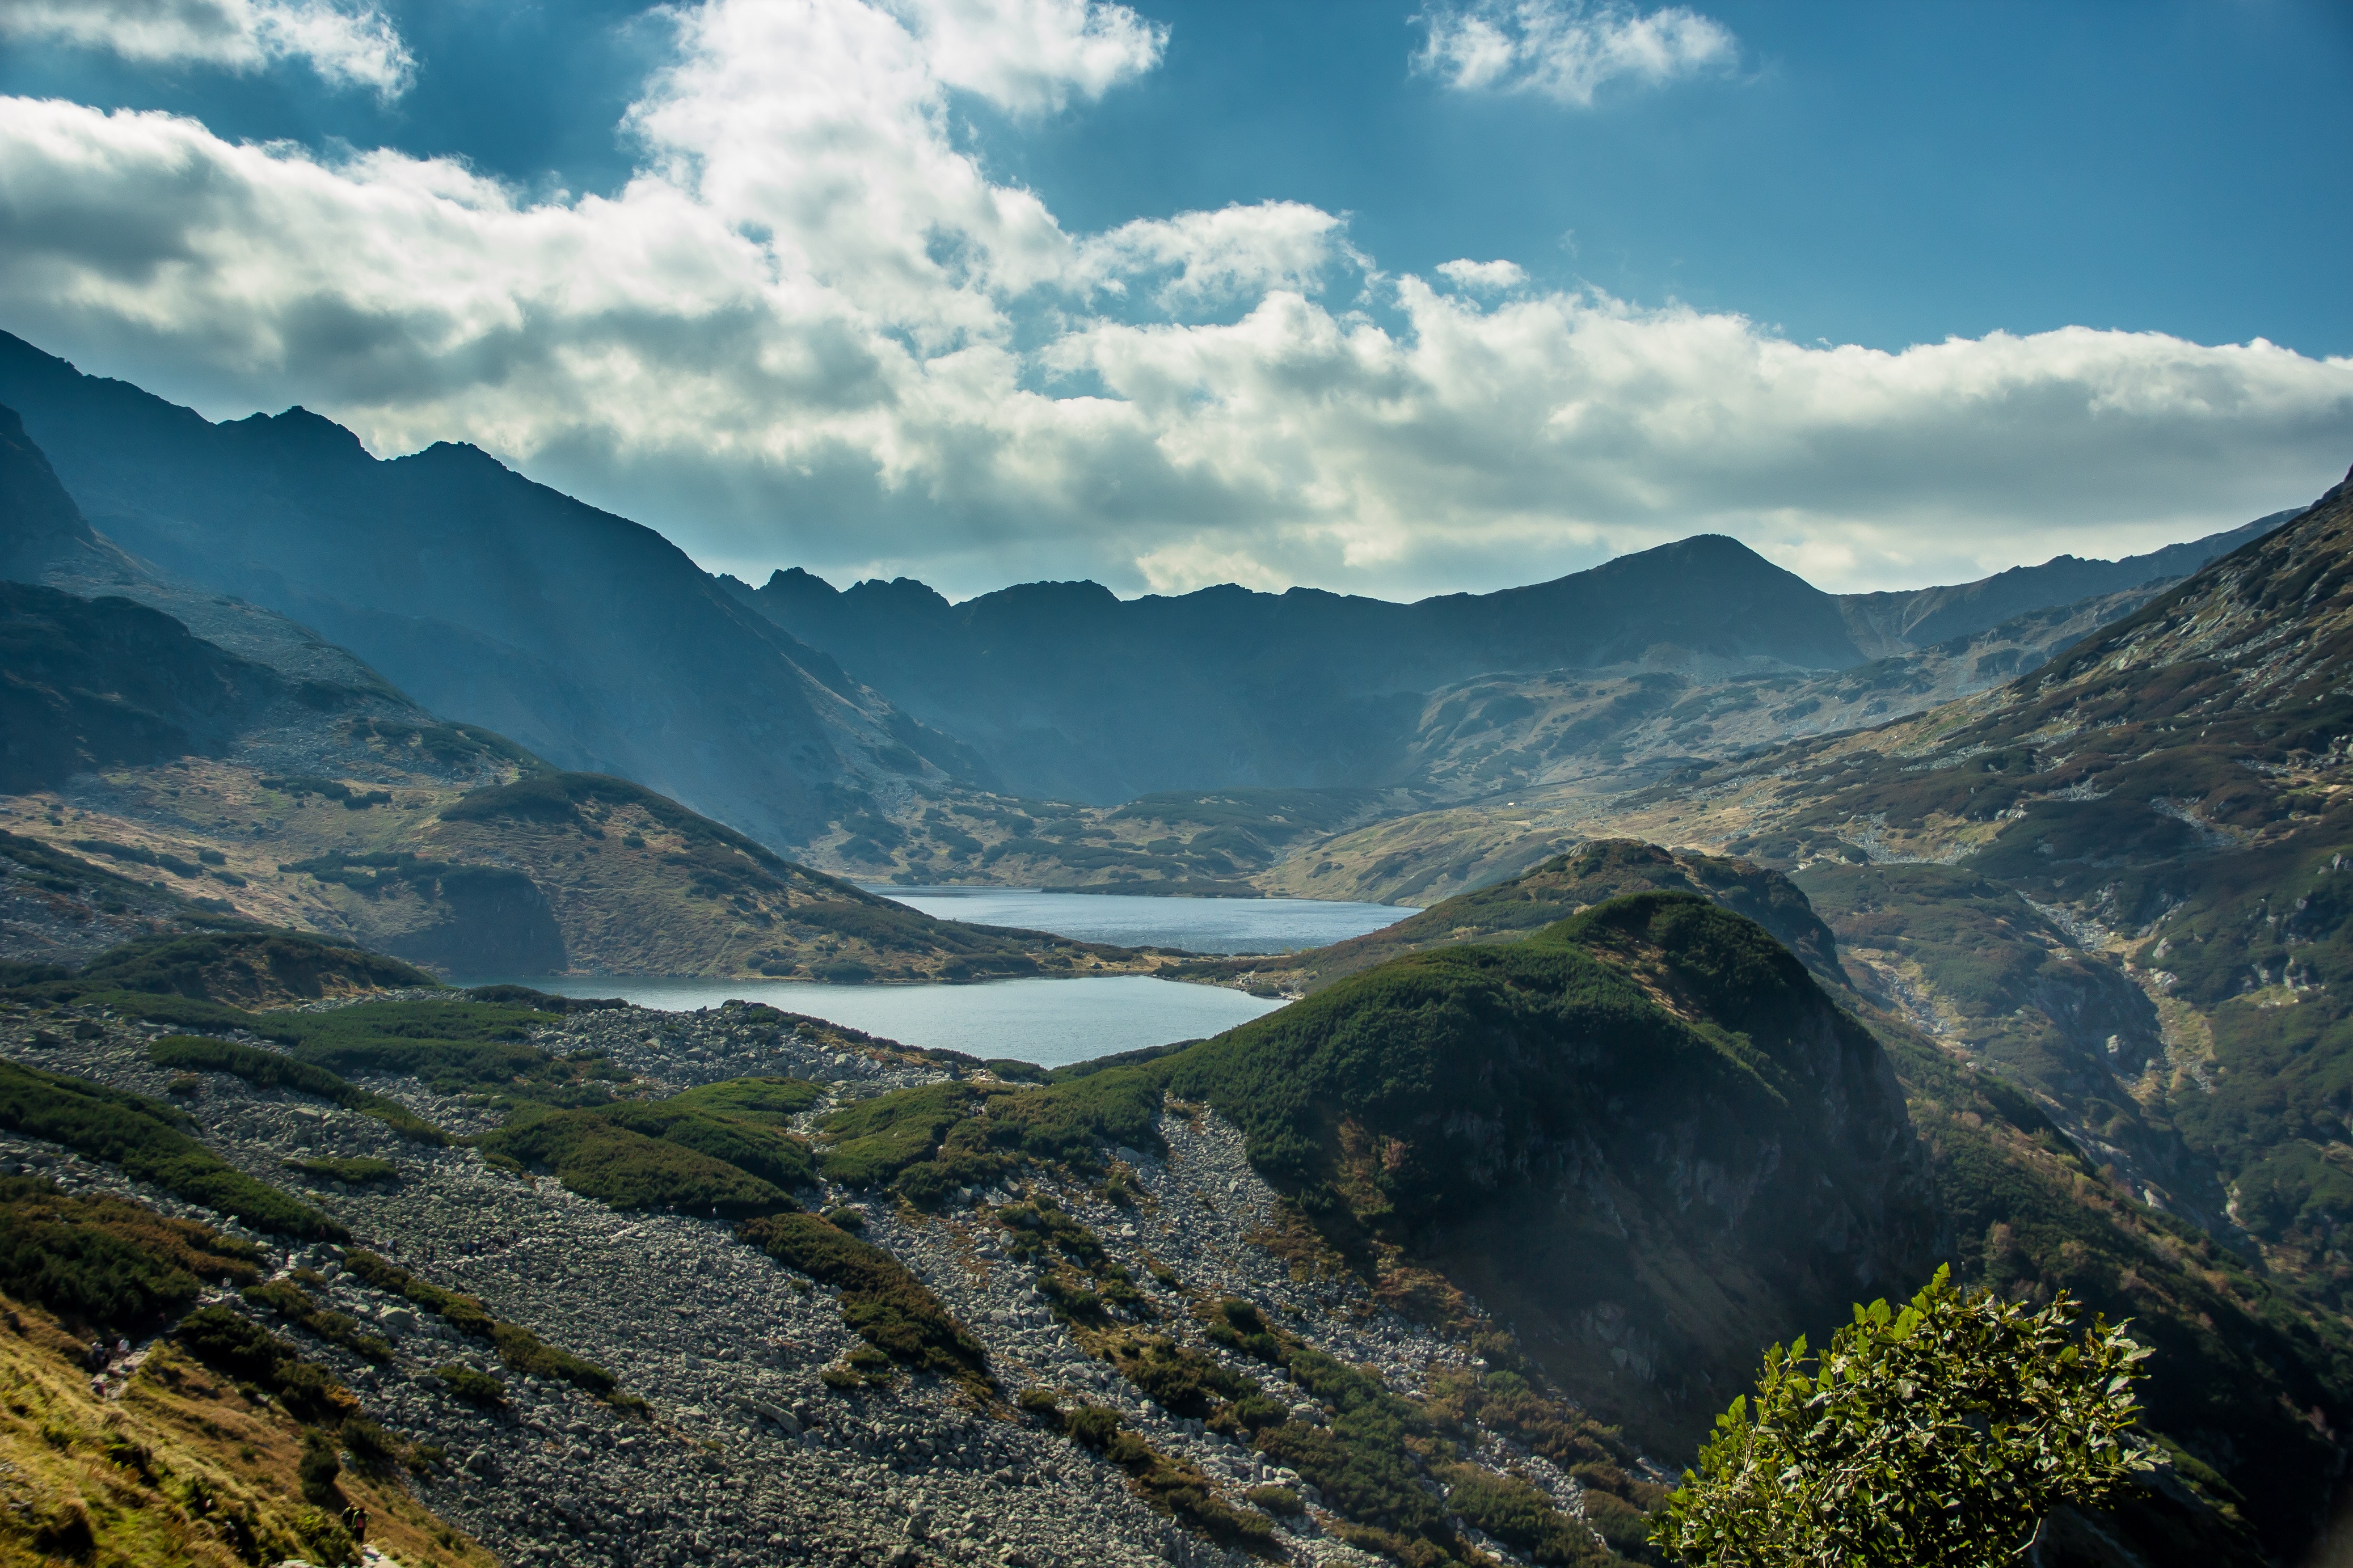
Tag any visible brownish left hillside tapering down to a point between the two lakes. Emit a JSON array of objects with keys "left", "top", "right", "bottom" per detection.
[{"left": 0, "top": 416, "right": 1153, "bottom": 980}]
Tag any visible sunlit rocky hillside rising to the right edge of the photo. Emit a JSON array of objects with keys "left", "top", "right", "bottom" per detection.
[{"left": 1430, "top": 465, "right": 2353, "bottom": 1303}]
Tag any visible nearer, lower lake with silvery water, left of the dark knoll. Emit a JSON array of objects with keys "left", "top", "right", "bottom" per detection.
[{"left": 487, "top": 975, "right": 1280, "bottom": 1067}]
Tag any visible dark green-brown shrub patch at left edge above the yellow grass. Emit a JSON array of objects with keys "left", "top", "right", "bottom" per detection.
[{"left": 0, "top": 1176, "right": 259, "bottom": 1333}]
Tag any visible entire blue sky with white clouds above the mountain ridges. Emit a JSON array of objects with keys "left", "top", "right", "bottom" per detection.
[{"left": 0, "top": 0, "right": 2353, "bottom": 599}]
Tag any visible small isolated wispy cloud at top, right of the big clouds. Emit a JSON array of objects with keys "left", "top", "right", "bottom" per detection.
[{"left": 1414, "top": 0, "right": 1739, "bottom": 108}]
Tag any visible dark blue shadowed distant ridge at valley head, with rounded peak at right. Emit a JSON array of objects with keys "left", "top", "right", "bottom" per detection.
[{"left": 748, "top": 536, "right": 1861, "bottom": 804}]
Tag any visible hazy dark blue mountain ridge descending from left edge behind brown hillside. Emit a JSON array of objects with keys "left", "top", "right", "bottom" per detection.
[{"left": 0, "top": 334, "right": 967, "bottom": 860}]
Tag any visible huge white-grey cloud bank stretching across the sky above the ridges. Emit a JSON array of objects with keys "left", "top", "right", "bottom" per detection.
[{"left": 0, "top": 0, "right": 2353, "bottom": 597}]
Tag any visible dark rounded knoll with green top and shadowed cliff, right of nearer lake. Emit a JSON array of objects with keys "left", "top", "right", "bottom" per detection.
[{"left": 1167, "top": 893, "right": 1937, "bottom": 1448}]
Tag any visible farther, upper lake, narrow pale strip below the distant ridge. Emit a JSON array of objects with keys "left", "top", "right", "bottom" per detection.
[{"left": 866, "top": 886, "right": 1419, "bottom": 952}]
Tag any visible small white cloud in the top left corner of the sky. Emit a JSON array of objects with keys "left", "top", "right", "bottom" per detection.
[{"left": 0, "top": 0, "right": 416, "bottom": 99}]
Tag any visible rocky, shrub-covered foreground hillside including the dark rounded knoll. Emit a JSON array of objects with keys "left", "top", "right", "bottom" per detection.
[{"left": 18, "top": 884, "right": 2353, "bottom": 1568}]
